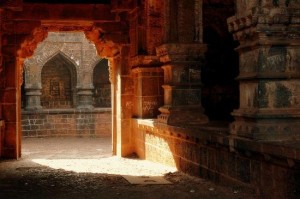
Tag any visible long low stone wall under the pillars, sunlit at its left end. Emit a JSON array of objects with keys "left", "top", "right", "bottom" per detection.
[{"left": 132, "top": 119, "right": 300, "bottom": 199}]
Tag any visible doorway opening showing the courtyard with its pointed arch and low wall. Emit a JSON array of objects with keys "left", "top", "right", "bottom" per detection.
[{"left": 21, "top": 32, "right": 112, "bottom": 159}]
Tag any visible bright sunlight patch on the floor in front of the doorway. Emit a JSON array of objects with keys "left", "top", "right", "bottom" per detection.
[{"left": 32, "top": 156, "right": 177, "bottom": 176}]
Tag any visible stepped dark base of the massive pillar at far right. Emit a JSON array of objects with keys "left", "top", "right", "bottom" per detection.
[{"left": 230, "top": 110, "right": 300, "bottom": 141}]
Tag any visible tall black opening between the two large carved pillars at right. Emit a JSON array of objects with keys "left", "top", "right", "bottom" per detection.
[{"left": 201, "top": 0, "right": 239, "bottom": 123}]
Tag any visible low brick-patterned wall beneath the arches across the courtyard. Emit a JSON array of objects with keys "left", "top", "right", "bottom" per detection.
[{"left": 22, "top": 108, "right": 111, "bottom": 137}]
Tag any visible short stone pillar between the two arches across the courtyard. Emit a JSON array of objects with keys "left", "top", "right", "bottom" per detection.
[{"left": 77, "top": 85, "right": 94, "bottom": 109}]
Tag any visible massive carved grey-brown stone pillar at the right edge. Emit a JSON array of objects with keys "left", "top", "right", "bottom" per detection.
[{"left": 228, "top": 0, "right": 300, "bottom": 140}]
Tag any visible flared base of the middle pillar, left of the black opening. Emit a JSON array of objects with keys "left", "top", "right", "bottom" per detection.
[{"left": 158, "top": 106, "right": 209, "bottom": 126}]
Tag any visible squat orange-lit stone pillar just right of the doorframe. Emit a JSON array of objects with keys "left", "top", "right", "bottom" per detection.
[{"left": 131, "top": 56, "right": 163, "bottom": 118}]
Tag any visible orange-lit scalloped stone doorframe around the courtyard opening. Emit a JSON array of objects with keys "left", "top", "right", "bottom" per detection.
[{"left": 2, "top": 20, "right": 132, "bottom": 159}]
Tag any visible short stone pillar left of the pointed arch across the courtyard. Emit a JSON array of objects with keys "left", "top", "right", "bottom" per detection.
[{"left": 25, "top": 83, "right": 42, "bottom": 110}]
